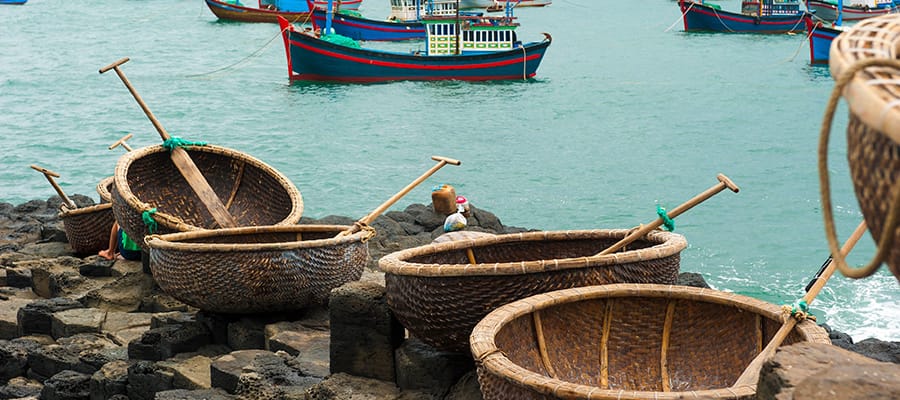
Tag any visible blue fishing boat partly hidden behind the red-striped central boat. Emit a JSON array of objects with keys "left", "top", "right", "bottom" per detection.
[{"left": 312, "top": 0, "right": 457, "bottom": 41}]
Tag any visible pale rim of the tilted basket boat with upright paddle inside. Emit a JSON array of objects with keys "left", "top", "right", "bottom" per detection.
[{"left": 113, "top": 144, "right": 303, "bottom": 231}]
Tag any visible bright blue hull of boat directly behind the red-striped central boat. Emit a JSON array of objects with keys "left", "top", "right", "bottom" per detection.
[{"left": 312, "top": 10, "right": 425, "bottom": 41}]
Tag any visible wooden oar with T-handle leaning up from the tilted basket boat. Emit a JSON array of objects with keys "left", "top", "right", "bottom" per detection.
[{"left": 100, "top": 57, "right": 237, "bottom": 228}]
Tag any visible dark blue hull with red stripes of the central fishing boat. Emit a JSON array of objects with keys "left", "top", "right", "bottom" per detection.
[{"left": 279, "top": 19, "right": 551, "bottom": 83}]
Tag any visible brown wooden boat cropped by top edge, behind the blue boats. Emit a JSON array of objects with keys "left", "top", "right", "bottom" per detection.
[{"left": 204, "top": 0, "right": 362, "bottom": 23}]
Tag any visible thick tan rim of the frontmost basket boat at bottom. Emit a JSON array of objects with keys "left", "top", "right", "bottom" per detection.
[{"left": 469, "top": 283, "right": 827, "bottom": 400}]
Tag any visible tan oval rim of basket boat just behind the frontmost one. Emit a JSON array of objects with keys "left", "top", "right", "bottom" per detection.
[{"left": 378, "top": 229, "right": 687, "bottom": 277}]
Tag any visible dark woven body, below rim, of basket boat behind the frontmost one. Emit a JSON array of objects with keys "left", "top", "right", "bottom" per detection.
[{"left": 385, "top": 232, "right": 680, "bottom": 352}]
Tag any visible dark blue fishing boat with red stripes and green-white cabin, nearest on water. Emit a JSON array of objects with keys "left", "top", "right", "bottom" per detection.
[{"left": 278, "top": 0, "right": 552, "bottom": 83}]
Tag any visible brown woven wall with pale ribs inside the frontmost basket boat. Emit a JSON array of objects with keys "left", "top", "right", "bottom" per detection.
[{"left": 473, "top": 285, "right": 828, "bottom": 400}]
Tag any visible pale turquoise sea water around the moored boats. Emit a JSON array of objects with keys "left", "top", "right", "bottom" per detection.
[{"left": 0, "top": 0, "right": 900, "bottom": 341}]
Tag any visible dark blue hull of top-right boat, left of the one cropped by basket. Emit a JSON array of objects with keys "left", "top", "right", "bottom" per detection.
[{"left": 678, "top": 0, "right": 806, "bottom": 33}]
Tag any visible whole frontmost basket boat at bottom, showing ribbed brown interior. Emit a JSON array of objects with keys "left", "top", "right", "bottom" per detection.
[{"left": 470, "top": 284, "right": 830, "bottom": 400}]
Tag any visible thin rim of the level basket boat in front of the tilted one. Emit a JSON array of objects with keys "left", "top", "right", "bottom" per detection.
[{"left": 144, "top": 224, "right": 375, "bottom": 253}]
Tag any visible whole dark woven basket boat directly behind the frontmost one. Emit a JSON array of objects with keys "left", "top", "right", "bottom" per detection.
[{"left": 379, "top": 229, "right": 687, "bottom": 352}]
